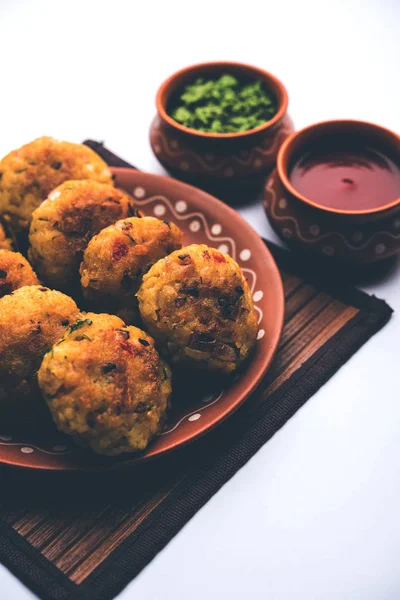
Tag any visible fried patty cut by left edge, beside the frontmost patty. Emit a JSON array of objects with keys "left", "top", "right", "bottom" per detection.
[{"left": 0, "top": 285, "right": 79, "bottom": 420}]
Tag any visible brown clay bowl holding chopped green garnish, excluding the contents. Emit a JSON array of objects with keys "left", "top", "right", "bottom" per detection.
[{"left": 150, "top": 62, "right": 294, "bottom": 201}]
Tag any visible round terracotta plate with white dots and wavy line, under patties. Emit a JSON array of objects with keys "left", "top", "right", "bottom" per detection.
[{"left": 0, "top": 169, "right": 284, "bottom": 471}]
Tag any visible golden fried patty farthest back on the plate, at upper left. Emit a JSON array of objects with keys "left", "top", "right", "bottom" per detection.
[{"left": 0, "top": 137, "right": 112, "bottom": 232}]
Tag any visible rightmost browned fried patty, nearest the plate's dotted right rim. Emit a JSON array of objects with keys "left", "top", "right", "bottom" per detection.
[{"left": 137, "top": 244, "right": 257, "bottom": 373}]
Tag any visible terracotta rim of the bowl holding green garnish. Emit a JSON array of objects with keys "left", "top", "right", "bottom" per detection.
[{"left": 156, "top": 61, "right": 289, "bottom": 140}]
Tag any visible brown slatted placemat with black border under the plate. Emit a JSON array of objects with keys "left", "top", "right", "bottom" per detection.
[{"left": 0, "top": 142, "right": 392, "bottom": 600}]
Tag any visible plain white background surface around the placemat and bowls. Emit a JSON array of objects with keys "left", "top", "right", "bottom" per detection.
[{"left": 0, "top": 0, "right": 400, "bottom": 600}]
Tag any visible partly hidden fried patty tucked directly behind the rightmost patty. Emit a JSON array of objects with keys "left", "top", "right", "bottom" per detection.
[{"left": 80, "top": 217, "right": 183, "bottom": 323}]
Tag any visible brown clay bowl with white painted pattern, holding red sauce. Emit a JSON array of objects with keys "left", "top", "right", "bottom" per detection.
[{"left": 264, "top": 121, "right": 400, "bottom": 265}]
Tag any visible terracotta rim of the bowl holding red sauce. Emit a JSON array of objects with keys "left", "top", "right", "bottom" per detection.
[{"left": 277, "top": 119, "right": 400, "bottom": 215}]
